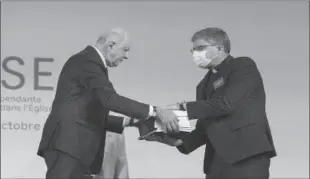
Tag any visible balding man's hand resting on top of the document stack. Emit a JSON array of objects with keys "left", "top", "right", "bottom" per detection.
[{"left": 155, "top": 107, "right": 180, "bottom": 133}]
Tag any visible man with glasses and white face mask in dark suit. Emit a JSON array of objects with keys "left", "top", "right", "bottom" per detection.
[{"left": 148, "top": 28, "right": 276, "bottom": 179}]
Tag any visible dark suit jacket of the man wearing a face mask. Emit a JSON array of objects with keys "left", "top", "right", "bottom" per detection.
[{"left": 178, "top": 56, "right": 276, "bottom": 173}]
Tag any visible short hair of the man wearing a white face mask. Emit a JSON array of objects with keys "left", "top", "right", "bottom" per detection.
[{"left": 191, "top": 27, "right": 231, "bottom": 53}]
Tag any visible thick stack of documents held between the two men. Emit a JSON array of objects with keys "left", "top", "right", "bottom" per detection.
[{"left": 138, "top": 110, "right": 194, "bottom": 140}]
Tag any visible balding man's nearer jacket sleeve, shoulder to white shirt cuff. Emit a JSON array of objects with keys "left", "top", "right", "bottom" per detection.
[{"left": 80, "top": 60, "right": 149, "bottom": 119}]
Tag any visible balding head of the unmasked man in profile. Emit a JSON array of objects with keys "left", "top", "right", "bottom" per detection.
[{"left": 95, "top": 28, "right": 130, "bottom": 67}]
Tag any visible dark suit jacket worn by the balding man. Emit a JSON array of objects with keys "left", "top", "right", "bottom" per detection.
[{"left": 37, "top": 46, "right": 149, "bottom": 173}]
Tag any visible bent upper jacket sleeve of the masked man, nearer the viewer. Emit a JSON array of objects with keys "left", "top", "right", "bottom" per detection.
[{"left": 186, "top": 58, "right": 262, "bottom": 119}]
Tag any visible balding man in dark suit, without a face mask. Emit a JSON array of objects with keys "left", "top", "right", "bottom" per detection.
[{"left": 37, "top": 28, "right": 179, "bottom": 178}]
